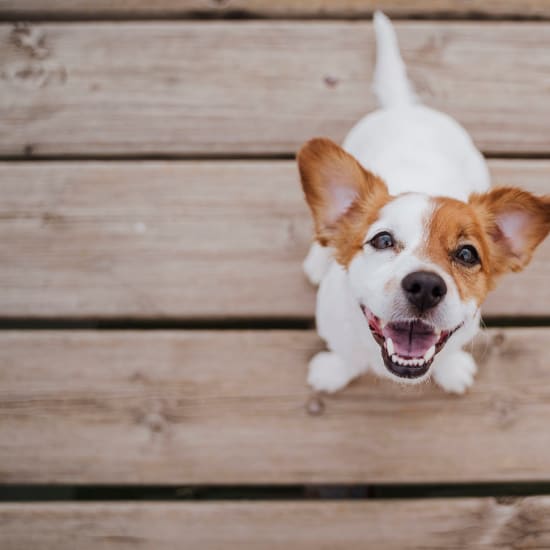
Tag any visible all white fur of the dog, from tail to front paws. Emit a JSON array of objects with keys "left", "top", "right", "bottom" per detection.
[{"left": 304, "top": 10, "right": 490, "bottom": 393}]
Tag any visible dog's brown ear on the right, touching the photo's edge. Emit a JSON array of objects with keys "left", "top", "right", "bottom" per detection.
[{"left": 470, "top": 187, "right": 550, "bottom": 275}]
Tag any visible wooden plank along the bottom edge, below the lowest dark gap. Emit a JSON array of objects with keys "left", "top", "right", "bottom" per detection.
[{"left": 4, "top": 497, "right": 550, "bottom": 550}]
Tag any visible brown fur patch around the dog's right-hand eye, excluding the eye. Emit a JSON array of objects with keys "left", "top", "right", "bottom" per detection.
[{"left": 422, "top": 197, "right": 493, "bottom": 304}]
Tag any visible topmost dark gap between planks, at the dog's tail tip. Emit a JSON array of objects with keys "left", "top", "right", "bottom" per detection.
[{"left": 0, "top": 10, "right": 550, "bottom": 23}]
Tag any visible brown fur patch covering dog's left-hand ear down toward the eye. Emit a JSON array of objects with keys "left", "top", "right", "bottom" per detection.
[{"left": 297, "top": 138, "right": 390, "bottom": 254}]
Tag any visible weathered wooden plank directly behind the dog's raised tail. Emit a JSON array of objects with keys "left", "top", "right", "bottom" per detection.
[{"left": 0, "top": 21, "right": 550, "bottom": 156}]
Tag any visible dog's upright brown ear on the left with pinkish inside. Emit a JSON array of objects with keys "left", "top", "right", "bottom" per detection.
[{"left": 297, "top": 138, "right": 388, "bottom": 245}]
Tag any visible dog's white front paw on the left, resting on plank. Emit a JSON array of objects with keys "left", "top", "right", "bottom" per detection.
[{"left": 307, "top": 351, "right": 367, "bottom": 393}]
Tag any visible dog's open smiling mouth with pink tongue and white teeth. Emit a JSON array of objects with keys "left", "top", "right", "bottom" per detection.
[{"left": 361, "top": 305, "right": 462, "bottom": 378}]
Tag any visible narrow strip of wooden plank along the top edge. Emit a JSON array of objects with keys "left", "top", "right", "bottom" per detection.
[{"left": 0, "top": 0, "right": 550, "bottom": 18}]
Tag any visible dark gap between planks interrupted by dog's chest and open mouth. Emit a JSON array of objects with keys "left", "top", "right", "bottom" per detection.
[{"left": 0, "top": 316, "right": 550, "bottom": 331}]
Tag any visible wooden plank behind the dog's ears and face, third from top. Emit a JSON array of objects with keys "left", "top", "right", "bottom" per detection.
[{"left": 0, "top": 161, "right": 550, "bottom": 319}]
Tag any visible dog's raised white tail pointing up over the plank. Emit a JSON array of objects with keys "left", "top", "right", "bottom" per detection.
[{"left": 372, "top": 11, "right": 418, "bottom": 107}]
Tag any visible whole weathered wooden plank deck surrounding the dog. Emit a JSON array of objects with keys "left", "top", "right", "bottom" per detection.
[{"left": 0, "top": 0, "right": 550, "bottom": 550}]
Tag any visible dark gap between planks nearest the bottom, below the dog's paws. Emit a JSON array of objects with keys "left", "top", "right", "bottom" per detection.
[{"left": 0, "top": 481, "right": 550, "bottom": 502}]
